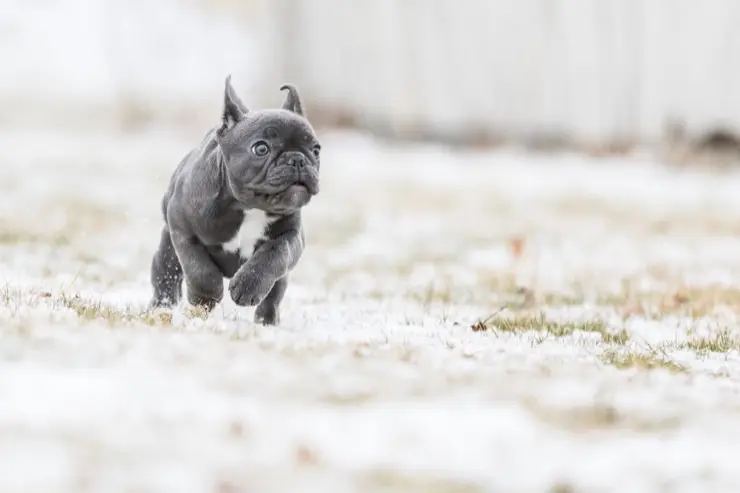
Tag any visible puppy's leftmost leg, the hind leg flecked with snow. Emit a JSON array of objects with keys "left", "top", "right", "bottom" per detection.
[{"left": 149, "top": 226, "right": 183, "bottom": 308}]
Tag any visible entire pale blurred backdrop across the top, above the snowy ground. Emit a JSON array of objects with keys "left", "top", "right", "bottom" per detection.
[{"left": 0, "top": 0, "right": 740, "bottom": 160}]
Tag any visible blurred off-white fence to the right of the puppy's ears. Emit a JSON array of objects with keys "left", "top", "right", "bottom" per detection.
[{"left": 264, "top": 0, "right": 740, "bottom": 146}]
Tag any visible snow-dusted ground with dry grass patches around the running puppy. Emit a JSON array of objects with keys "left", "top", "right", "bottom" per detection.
[{"left": 0, "top": 128, "right": 740, "bottom": 493}]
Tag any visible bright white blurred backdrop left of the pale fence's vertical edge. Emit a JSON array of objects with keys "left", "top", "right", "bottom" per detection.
[{"left": 0, "top": 0, "right": 270, "bottom": 131}]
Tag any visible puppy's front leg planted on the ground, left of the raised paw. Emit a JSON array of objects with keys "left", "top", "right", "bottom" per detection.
[{"left": 172, "top": 231, "right": 224, "bottom": 311}]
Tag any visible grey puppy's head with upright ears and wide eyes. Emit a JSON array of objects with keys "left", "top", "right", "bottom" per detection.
[{"left": 216, "top": 76, "right": 321, "bottom": 214}]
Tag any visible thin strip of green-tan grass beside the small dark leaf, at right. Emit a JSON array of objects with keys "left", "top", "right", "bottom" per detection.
[{"left": 471, "top": 310, "right": 629, "bottom": 345}]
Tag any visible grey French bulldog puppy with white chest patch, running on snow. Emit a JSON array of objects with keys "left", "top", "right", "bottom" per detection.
[{"left": 150, "top": 75, "right": 321, "bottom": 325}]
